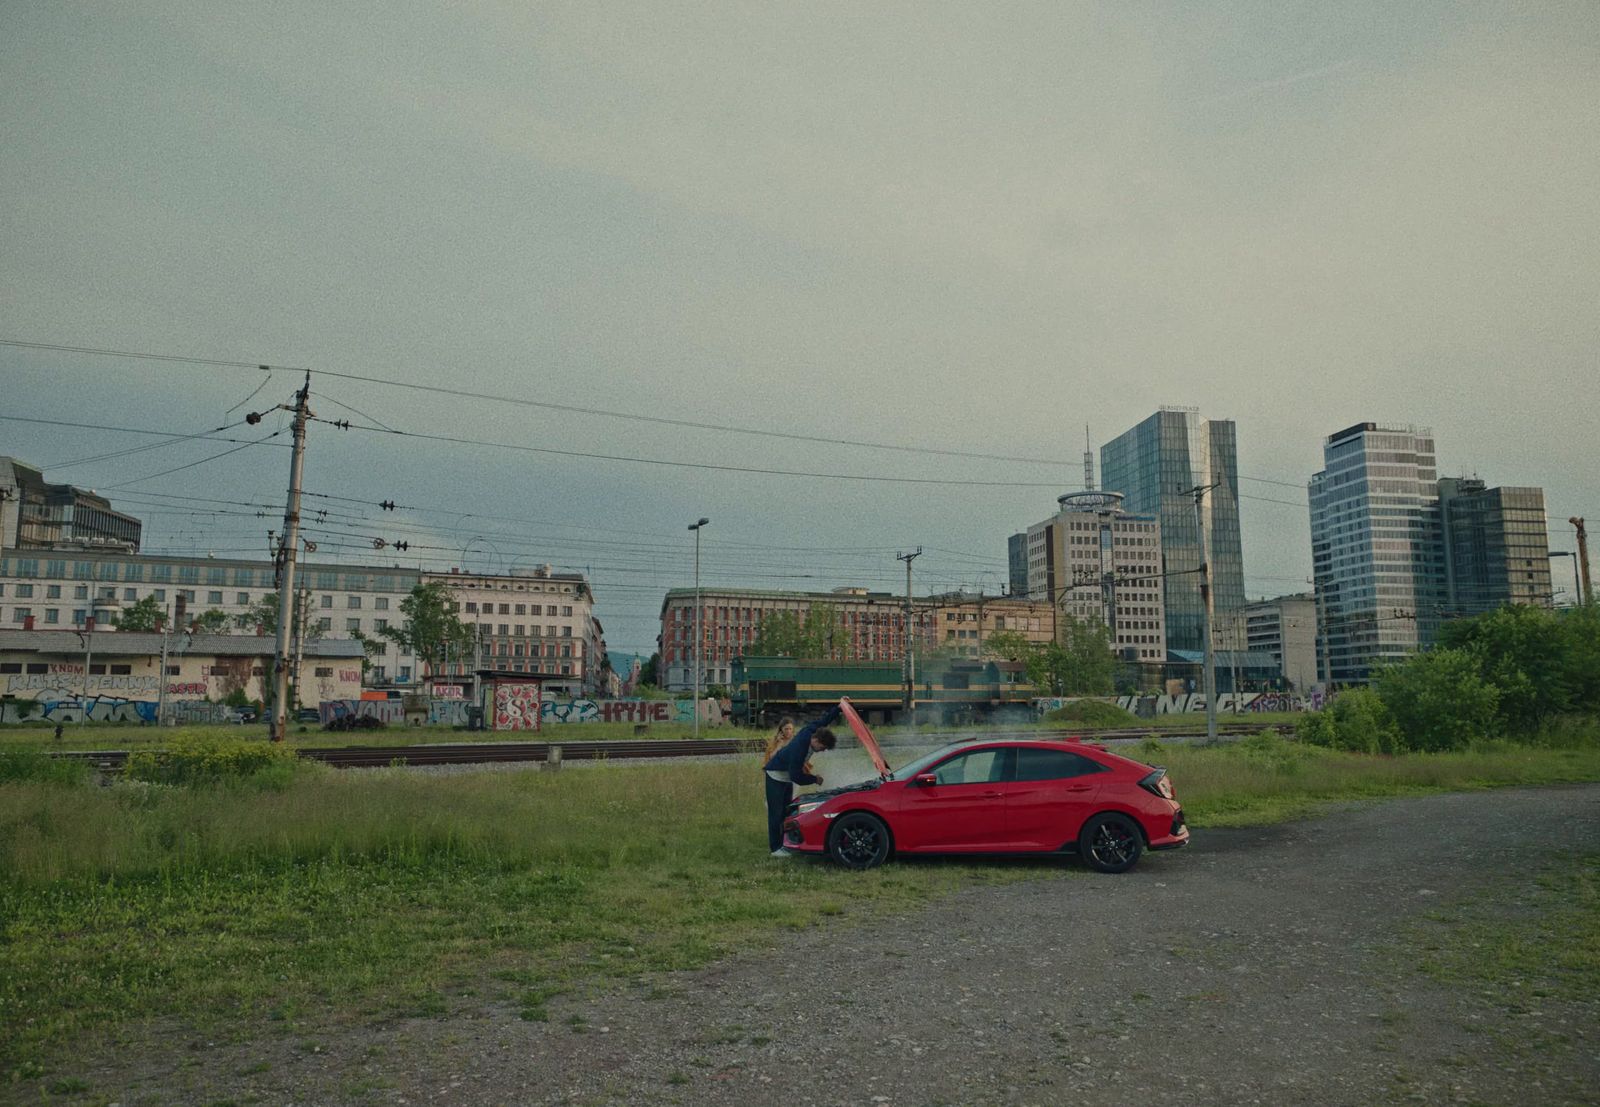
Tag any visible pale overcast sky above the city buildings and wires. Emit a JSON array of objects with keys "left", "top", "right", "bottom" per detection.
[{"left": 0, "top": 0, "right": 1600, "bottom": 651}]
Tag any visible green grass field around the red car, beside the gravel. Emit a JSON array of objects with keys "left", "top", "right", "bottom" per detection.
[{"left": 0, "top": 736, "right": 1600, "bottom": 1075}]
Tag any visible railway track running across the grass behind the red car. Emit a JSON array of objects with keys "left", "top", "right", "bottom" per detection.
[{"left": 53, "top": 723, "right": 1277, "bottom": 773}]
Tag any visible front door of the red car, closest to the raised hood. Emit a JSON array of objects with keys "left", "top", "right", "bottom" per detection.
[{"left": 894, "top": 745, "right": 1010, "bottom": 853}]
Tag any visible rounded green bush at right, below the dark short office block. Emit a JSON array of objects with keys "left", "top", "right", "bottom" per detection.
[{"left": 1378, "top": 649, "right": 1501, "bottom": 750}]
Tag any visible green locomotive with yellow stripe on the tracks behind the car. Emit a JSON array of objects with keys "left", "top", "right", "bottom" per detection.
[{"left": 733, "top": 657, "right": 1034, "bottom": 726}]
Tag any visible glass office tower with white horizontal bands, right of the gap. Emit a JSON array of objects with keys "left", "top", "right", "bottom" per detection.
[{"left": 1307, "top": 422, "right": 1445, "bottom": 685}]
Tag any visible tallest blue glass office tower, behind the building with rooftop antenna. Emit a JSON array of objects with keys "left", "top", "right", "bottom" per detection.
[{"left": 1101, "top": 408, "right": 1245, "bottom": 649}]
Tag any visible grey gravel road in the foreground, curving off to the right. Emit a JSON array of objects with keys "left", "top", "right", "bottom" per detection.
[{"left": 56, "top": 785, "right": 1600, "bottom": 1107}]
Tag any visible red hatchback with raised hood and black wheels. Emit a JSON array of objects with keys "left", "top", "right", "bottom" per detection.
[{"left": 784, "top": 701, "right": 1189, "bottom": 872}]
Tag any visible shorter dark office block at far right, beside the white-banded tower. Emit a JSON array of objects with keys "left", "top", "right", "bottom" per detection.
[{"left": 1438, "top": 477, "right": 1552, "bottom": 614}]
